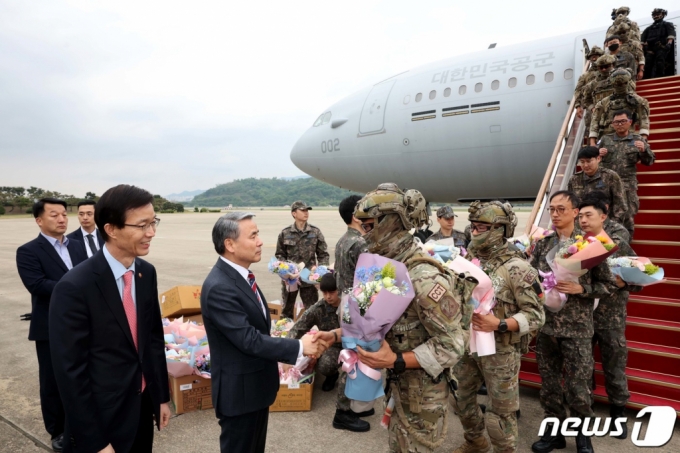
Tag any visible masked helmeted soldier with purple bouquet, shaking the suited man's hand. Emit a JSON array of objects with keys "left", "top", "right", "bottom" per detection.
[{"left": 354, "top": 183, "right": 476, "bottom": 453}]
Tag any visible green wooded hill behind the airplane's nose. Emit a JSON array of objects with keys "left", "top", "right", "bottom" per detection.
[{"left": 187, "top": 178, "right": 361, "bottom": 207}]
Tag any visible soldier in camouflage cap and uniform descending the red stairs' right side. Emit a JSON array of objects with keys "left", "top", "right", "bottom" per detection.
[{"left": 600, "top": 110, "right": 655, "bottom": 239}]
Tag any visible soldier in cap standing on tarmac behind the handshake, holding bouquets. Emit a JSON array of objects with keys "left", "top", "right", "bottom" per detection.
[{"left": 276, "top": 201, "right": 330, "bottom": 318}]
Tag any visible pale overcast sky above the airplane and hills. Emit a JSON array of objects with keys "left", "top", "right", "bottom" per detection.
[{"left": 0, "top": 0, "right": 677, "bottom": 196}]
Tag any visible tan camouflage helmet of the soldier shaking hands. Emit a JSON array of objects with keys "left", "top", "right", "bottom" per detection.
[{"left": 354, "top": 182, "right": 430, "bottom": 230}]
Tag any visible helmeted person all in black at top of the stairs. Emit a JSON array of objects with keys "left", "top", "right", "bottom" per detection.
[{"left": 640, "top": 8, "right": 676, "bottom": 79}]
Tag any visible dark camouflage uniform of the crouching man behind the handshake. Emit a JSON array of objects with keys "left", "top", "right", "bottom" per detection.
[{"left": 288, "top": 298, "right": 350, "bottom": 411}]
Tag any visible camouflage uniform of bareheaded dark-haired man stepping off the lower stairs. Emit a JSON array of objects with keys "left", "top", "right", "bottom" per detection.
[{"left": 567, "top": 168, "right": 628, "bottom": 222}]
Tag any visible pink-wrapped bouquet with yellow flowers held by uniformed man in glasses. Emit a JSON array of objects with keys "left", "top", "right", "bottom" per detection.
[{"left": 539, "top": 232, "right": 619, "bottom": 313}]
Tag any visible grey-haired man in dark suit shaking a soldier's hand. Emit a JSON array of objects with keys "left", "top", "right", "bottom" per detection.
[{"left": 201, "top": 212, "right": 326, "bottom": 453}]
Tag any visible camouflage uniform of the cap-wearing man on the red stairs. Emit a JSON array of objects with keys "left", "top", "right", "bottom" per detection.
[{"left": 599, "top": 133, "right": 655, "bottom": 238}]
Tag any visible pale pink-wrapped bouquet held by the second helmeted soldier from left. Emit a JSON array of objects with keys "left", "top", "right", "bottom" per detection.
[{"left": 446, "top": 256, "right": 496, "bottom": 357}]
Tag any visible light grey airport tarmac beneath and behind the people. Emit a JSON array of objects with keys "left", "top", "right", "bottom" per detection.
[{"left": 0, "top": 212, "right": 680, "bottom": 453}]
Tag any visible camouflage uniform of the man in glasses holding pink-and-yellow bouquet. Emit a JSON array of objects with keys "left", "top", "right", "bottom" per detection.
[{"left": 531, "top": 228, "right": 616, "bottom": 421}]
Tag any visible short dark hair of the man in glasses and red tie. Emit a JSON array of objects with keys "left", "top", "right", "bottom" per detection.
[{"left": 94, "top": 184, "right": 153, "bottom": 242}]
